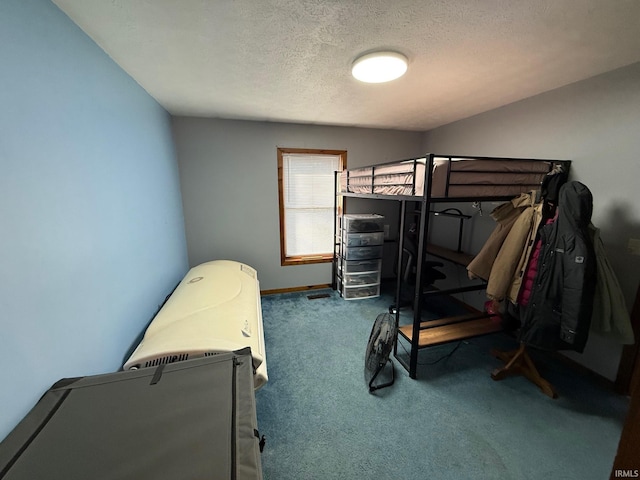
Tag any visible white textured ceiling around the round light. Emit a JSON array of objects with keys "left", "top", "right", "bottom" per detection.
[{"left": 54, "top": 0, "right": 640, "bottom": 130}]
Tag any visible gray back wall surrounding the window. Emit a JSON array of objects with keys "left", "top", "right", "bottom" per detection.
[{"left": 173, "top": 117, "right": 422, "bottom": 290}]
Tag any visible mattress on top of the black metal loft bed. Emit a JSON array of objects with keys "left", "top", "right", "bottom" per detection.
[{"left": 340, "top": 157, "right": 553, "bottom": 198}]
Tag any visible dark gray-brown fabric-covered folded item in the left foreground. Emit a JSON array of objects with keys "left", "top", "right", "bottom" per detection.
[{"left": 0, "top": 349, "right": 262, "bottom": 480}]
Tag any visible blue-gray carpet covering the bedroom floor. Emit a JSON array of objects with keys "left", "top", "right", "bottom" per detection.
[{"left": 257, "top": 290, "right": 628, "bottom": 480}]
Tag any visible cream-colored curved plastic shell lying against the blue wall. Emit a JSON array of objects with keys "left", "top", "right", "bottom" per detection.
[{"left": 123, "top": 260, "right": 268, "bottom": 389}]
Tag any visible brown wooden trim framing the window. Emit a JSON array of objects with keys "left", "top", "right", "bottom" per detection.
[{"left": 277, "top": 147, "right": 347, "bottom": 266}]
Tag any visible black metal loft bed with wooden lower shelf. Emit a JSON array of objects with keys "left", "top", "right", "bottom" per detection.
[{"left": 334, "top": 154, "right": 571, "bottom": 378}]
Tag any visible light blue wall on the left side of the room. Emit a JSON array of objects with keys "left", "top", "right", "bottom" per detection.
[{"left": 0, "top": 0, "right": 188, "bottom": 439}]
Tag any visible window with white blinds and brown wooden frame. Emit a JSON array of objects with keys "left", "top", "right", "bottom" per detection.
[{"left": 278, "top": 148, "right": 347, "bottom": 265}]
